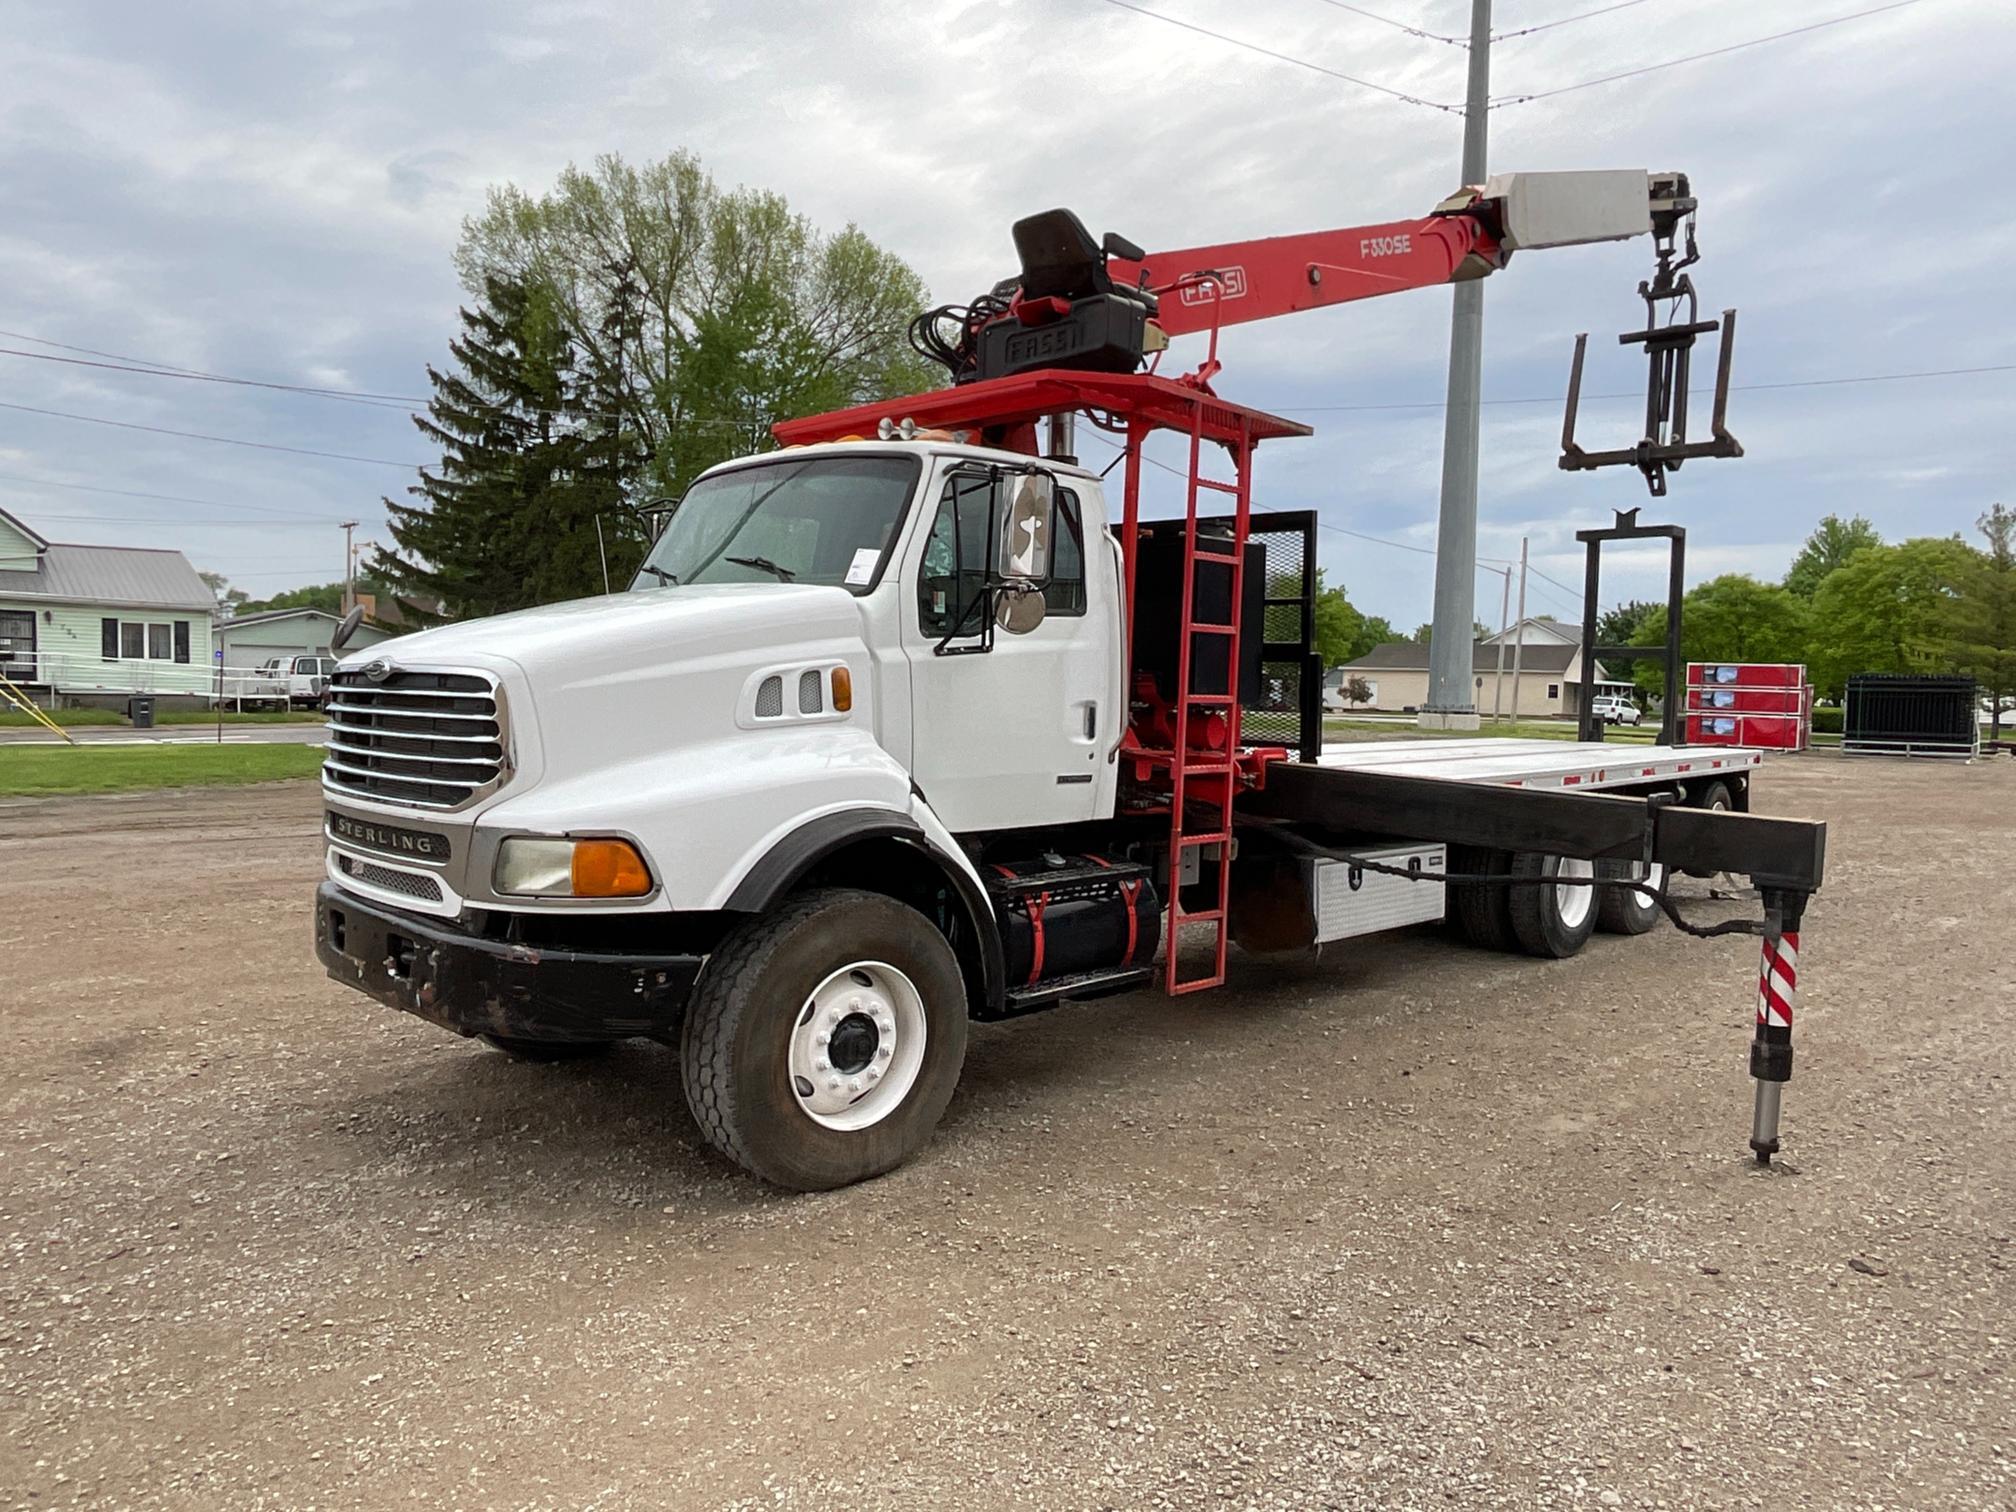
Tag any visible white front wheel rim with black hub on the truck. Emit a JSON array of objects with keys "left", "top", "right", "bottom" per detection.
[{"left": 786, "top": 962, "right": 927, "bottom": 1133}]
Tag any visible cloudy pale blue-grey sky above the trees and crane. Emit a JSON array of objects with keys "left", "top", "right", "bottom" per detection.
[{"left": 0, "top": 0, "right": 2016, "bottom": 631}]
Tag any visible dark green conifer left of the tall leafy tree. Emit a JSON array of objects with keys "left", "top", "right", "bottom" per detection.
[{"left": 371, "top": 278, "right": 643, "bottom": 619}]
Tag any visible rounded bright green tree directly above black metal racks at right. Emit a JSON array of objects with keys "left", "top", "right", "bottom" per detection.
[{"left": 1806, "top": 536, "right": 1980, "bottom": 698}]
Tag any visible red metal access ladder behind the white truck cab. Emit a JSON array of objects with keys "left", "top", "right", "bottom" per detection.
[{"left": 1163, "top": 405, "right": 1252, "bottom": 996}]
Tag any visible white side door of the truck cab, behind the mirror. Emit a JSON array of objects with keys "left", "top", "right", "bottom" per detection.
[{"left": 903, "top": 472, "right": 1119, "bottom": 833}]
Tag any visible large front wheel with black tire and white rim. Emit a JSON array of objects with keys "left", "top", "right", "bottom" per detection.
[{"left": 679, "top": 887, "right": 966, "bottom": 1191}]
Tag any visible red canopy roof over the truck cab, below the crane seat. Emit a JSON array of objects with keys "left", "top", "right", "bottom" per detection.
[{"left": 770, "top": 367, "right": 1310, "bottom": 446}]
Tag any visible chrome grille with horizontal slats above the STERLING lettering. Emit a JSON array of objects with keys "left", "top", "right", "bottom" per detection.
[{"left": 323, "top": 671, "right": 506, "bottom": 808}]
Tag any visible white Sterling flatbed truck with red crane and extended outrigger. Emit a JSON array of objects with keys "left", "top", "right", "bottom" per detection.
[{"left": 314, "top": 175, "right": 1824, "bottom": 1189}]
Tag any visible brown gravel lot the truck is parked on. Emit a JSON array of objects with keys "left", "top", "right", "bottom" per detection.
[{"left": 0, "top": 758, "right": 2016, "bottom": 1508}]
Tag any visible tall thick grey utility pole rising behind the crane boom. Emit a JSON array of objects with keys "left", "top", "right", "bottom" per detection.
[{"left": 1421, "top": 0, "right": 1518, "bottom": 730}]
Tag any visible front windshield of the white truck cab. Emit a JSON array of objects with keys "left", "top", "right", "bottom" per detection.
[{"left": 631, "top": 456, "right": 923, "bottom": 595}]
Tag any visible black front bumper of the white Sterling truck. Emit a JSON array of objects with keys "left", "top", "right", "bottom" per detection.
[{"left": 314, "top": 881, "right": 706, "bottom": 1040}]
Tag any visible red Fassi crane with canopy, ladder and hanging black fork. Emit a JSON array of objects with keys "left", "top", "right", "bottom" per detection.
[{"left": 772, "top": 171, "right": 1742, "bottom": 992}]
